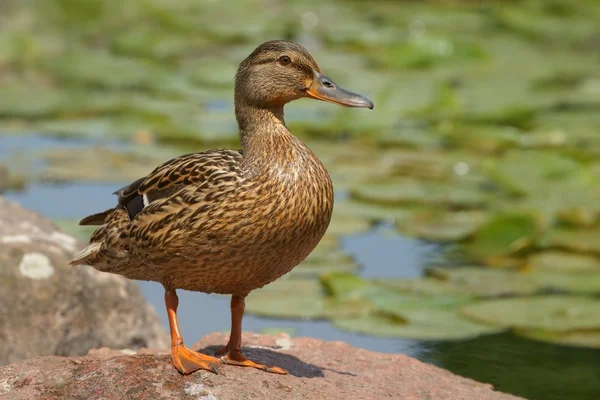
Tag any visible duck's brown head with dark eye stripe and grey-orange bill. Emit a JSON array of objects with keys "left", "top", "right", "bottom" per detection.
[{"left": 235, "top": 40, "right": 373, "bottom": 109}]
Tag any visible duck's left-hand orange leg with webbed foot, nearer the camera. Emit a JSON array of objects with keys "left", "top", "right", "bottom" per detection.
[{"left": 165, "top": 290, "right": 221, "bottom": 375}]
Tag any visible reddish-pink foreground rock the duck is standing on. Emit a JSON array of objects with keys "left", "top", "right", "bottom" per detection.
[{"left": 0, "top": 333, "right": 518, "bottom": 400}]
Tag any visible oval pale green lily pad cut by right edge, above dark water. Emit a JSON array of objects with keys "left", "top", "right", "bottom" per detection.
[{"left": 460, "top": 296, "right": 600, "bottom": 332}]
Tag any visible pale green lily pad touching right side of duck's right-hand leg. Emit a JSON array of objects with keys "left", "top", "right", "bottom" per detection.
[{"left": 246, "top": 278, "right": 331, "bottom": 319}]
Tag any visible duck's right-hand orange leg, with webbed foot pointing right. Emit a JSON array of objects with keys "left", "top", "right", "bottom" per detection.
[{"left": 215, "top": 295, "right": 287, "bottom": 375}]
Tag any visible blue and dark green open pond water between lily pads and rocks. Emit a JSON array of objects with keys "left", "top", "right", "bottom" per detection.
[{"left": 0, "top": 137, "right": 600, "bottom": 400}]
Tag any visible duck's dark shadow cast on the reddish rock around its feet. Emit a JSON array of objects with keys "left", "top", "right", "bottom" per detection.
[{"left": 199, "top": 346, "right": 325, "bottom": 378}]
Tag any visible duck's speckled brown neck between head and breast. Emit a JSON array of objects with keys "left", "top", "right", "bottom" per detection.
[{"left": 235, "top": 102, "right": 295, "bottom": 168}]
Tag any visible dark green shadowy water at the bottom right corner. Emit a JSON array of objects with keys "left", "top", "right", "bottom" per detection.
[{"left": 421, "top": 334, "right": 600, "bottom": 400}]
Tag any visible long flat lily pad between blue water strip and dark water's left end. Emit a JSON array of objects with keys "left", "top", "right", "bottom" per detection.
[{"left": 332, "top": 308, "right": 503, "bottom": 340}]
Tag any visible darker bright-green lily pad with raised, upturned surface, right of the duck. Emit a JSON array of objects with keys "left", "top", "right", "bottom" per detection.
[{"left": 465, "top": 213, "right": 538, "bottom": 261}]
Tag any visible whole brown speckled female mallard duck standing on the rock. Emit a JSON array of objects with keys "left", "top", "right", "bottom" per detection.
[{"left": 71, "top": 41, "right": 373, "bottom": 374}]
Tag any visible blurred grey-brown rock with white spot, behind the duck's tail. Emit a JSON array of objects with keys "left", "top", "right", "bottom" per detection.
[{"left": 0, "top": 197, "right": 170, "bottom": 368}]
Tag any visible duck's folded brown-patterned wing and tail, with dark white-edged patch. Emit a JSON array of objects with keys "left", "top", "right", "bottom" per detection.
[{"left": 71, "top": 149, "right": 243, "bottom": 265}]
